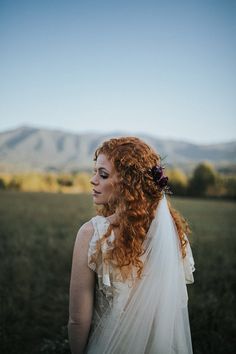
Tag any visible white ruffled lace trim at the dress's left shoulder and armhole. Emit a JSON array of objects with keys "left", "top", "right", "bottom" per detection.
[{"left": 88, "top": 215, "right": 115, "bottom": 306}]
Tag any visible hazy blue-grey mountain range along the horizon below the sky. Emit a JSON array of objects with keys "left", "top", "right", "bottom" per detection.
[{"left": 0, "top": 126, "right": 236, "bottom": 172}]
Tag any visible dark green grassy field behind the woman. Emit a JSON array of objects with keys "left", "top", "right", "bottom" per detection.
[{"left": 0, "top": 191, "right": 236, "bottom": 354}]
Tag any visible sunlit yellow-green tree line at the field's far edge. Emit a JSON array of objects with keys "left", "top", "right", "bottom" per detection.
[{"left": 0, "top": 162, "right": 236, "bottom": 199}]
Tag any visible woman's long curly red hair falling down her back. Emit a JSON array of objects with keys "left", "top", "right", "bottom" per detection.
[{"left": 91, "top": 137, "right": 190, "bottom": 279}]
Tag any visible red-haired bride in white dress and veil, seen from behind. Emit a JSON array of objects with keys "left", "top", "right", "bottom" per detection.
[{"left": 68, "top": 137, "right": 195, "bottom": 354}]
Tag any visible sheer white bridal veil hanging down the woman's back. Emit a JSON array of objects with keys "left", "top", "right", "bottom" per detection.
[{"left": 86, "top": 195, "right": 195, "bottom": 354}]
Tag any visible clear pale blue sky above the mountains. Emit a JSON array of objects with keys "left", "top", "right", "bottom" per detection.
[{"left": 0, "top": 0, "right": 236, "bottom": 143}]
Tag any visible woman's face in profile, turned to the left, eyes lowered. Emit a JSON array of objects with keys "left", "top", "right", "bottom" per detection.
[{"left": 90, "top": 154, "right": 118, "bottom": 205}]
